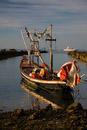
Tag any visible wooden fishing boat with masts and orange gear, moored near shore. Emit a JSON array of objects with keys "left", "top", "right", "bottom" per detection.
[{"left": 20, "top": 24, "right": 83, "bottom": 90}]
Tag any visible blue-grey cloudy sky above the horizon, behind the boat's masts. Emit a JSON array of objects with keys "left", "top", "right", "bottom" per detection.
[{"left": 0, "top": 0, "right": 87, "bottom": 49}]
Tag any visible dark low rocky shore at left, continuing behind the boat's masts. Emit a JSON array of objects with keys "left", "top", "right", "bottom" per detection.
[{"left": 0, "top": 49, "right": 47, "bottom": 60}]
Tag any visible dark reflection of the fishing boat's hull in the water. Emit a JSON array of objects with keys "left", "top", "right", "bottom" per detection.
[{"left": 20, "top": 79, "right": 74, "bottom": 108}]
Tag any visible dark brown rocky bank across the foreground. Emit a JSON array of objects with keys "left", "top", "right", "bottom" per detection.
[{"left": 0, "top": 102, "right": 87, "bottom": 130}]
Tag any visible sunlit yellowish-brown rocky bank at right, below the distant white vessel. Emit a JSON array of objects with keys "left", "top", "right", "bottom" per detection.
[{"left": 67, "top": 51, "right": 87, "bottom": 63}]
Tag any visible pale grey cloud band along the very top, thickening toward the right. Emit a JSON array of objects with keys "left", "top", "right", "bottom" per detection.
[{"left": 9, "top": 0, "right": 87, "bottom": 12}]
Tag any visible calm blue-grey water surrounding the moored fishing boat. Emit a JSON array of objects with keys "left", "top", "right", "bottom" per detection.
[{"left": 0, "top": 52, "right": 87, "bottom": 111}]
